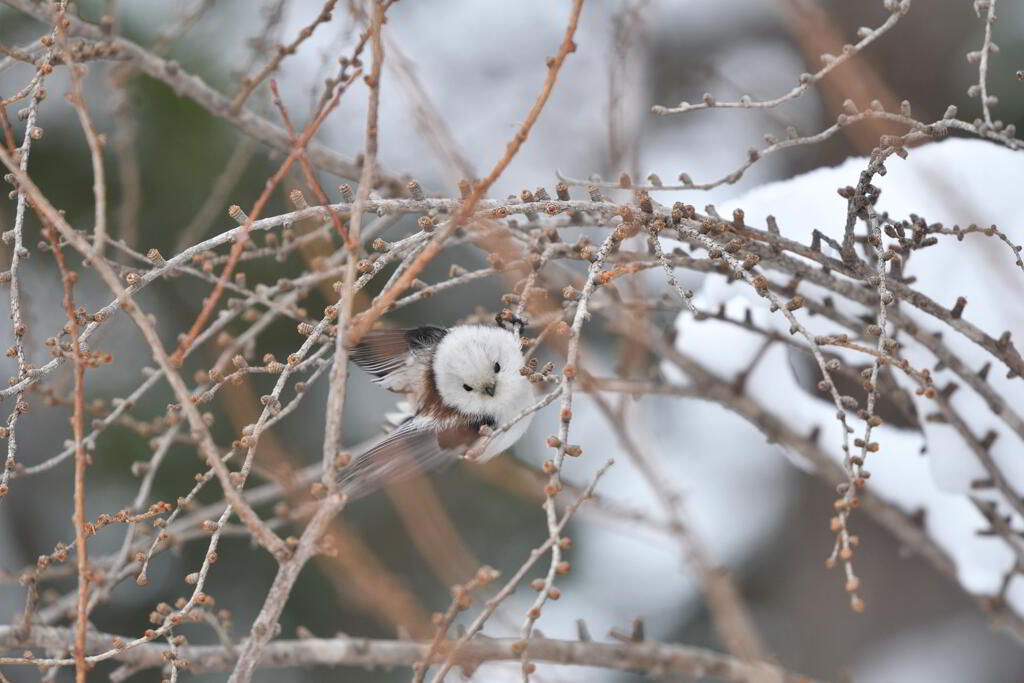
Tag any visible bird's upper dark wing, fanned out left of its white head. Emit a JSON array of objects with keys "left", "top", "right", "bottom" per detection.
[{"left": 349, "top": 325, "right": 447, "bottom": 393}]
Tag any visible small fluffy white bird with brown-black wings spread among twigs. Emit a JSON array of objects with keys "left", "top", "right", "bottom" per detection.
[{"left": 341, "top": 316, "right": 536, "bottom": 499}]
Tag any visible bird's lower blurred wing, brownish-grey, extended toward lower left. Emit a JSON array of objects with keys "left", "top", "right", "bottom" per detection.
[{"left": 341, "top": 418, "right": 487, "bottom": 499}]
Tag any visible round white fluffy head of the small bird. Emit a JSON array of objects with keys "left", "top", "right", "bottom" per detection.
[{"left": 433, "top": 325, "right": 530, "bottom": 420}]
